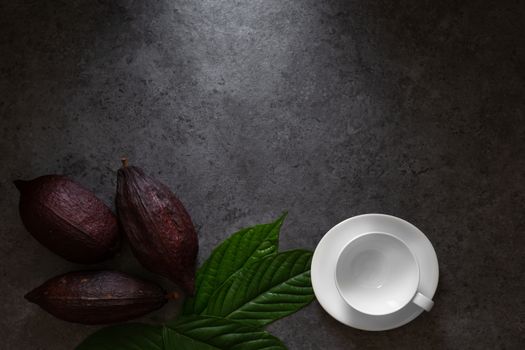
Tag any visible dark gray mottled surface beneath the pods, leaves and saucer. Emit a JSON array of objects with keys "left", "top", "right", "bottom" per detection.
[{"left": 0, "top": 0, "right": 525, "bottom": 350}]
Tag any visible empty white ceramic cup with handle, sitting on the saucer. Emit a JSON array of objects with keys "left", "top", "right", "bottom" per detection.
[{"left": 335, "top": 232, "right": 434, "bottom": 315}]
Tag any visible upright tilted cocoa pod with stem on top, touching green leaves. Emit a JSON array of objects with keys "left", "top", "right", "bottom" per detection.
[{"left": 116, "top": 160, "right": 199, "bottom": 294}]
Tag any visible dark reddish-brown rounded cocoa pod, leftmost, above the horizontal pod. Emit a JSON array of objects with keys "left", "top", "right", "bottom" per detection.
[{"left": 15, "top": 175, "right": 119, "bottom": 264}]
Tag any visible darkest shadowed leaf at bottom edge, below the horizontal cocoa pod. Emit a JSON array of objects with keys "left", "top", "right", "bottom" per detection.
[{"left": 76, "top": 323, "right": 164, "bottom": 350}]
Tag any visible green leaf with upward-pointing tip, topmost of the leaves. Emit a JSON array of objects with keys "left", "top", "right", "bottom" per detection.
[{"left": 184, "top": 213, "right": 286, "bottom": 314}]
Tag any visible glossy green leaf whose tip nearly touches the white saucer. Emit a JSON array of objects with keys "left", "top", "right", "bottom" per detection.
[{"left": 203, "top": 250, "right": 314, "bottom": 326}]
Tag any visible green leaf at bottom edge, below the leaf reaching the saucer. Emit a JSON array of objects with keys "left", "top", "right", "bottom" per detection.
[{"left": 162, "top": 316, "right": 286, "bottom": 350}]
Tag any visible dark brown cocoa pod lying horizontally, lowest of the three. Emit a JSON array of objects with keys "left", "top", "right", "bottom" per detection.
[{"left": 25, "top": 271, "right": 167, "bottom": 324}]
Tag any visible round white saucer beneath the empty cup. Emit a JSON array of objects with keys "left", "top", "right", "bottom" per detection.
[{"left": 311, "top": 214, "right": 439, "bottom": 331}]
